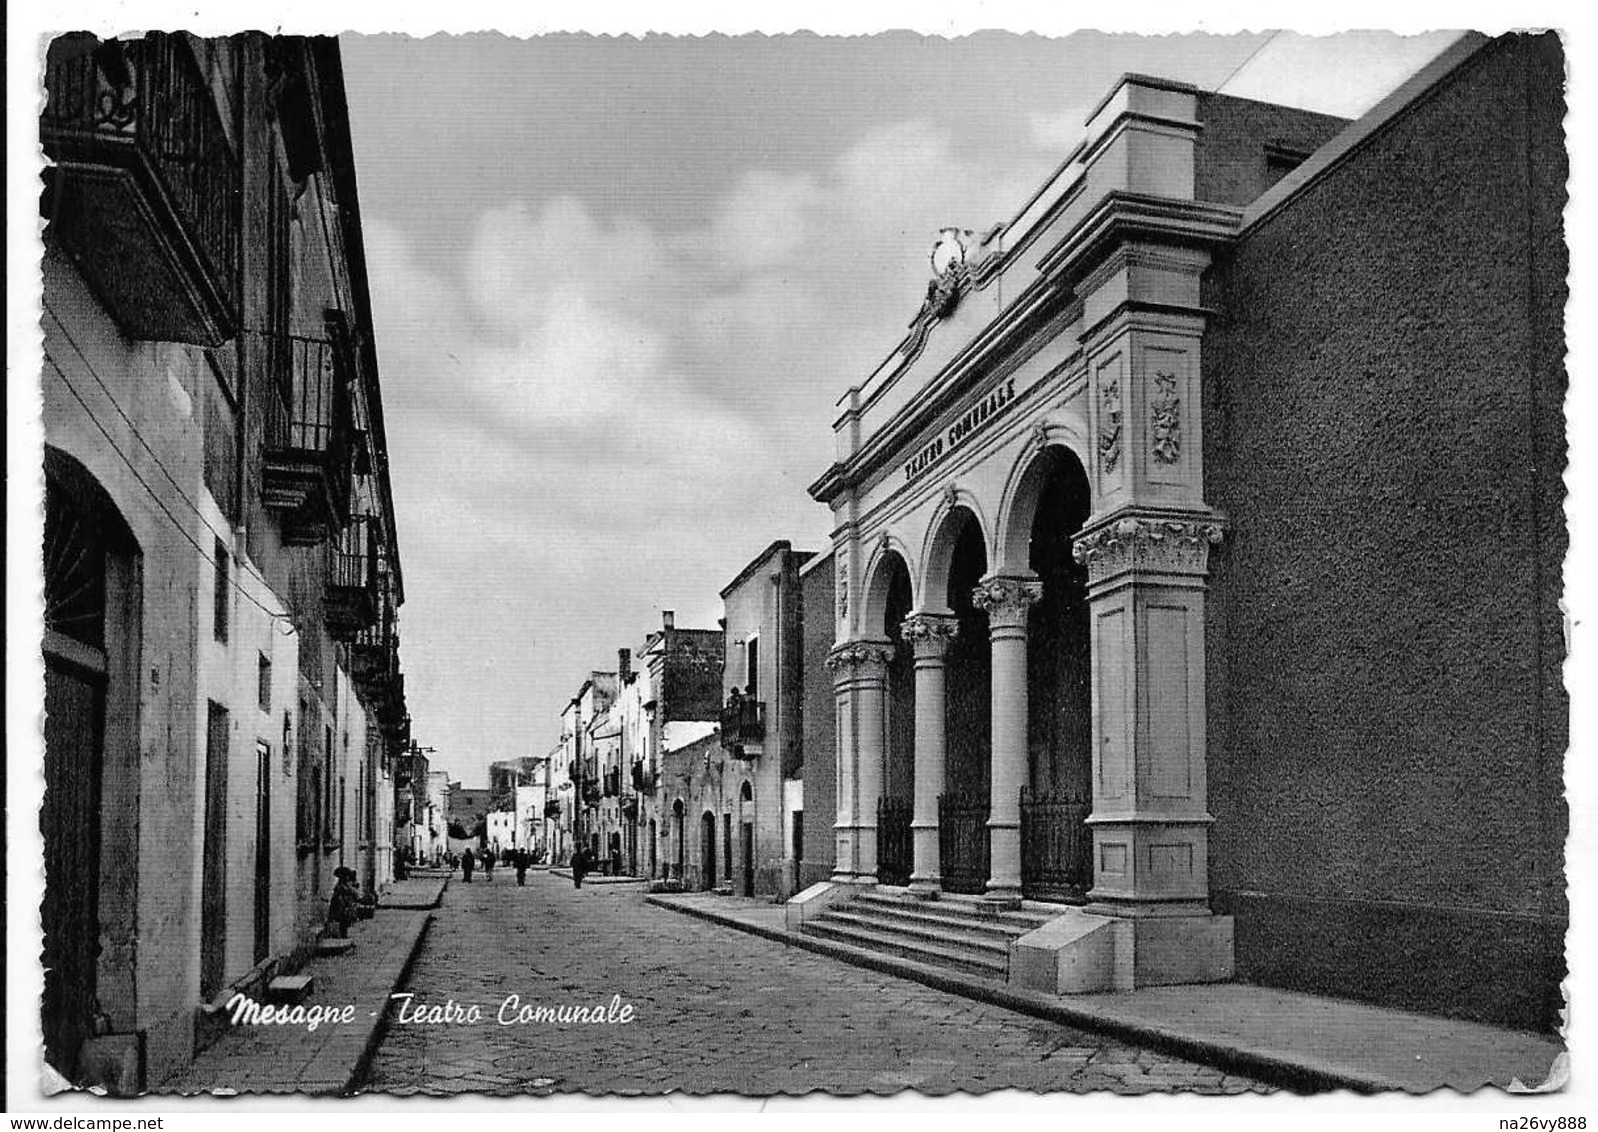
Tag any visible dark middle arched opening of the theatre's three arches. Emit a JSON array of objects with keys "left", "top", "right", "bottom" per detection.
[{"left": 938, "top": 508, "right": 992, "bottom": 892}]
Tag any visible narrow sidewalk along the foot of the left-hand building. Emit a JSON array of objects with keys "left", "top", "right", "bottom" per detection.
[{"left": 150, "top": 901, "right": 443, "bottom": 1095}]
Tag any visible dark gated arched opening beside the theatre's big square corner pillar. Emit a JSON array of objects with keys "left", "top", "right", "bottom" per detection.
[{"left": 1012, "top": 448, "right": 1093, "bottom": 902}]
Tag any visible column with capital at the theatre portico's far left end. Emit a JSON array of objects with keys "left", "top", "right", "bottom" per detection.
[{"left": 826, "top": 641, "right": 893, "bottom": 884}]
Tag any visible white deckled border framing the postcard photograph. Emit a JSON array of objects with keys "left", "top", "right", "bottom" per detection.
[{"left": 6, "top": 0, "right": 1598, "bottom": 1129}]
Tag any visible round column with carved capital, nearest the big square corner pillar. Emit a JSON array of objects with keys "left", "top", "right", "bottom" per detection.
[{"left": 972, "top": 576, "right": 1043, "bottom": 905}]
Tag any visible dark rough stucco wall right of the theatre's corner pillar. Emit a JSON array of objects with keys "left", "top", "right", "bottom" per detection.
[{"left": 1203, "top": 37, "right": 1568, "bottom": 1026}]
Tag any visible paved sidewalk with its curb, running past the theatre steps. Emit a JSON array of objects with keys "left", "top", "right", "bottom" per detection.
[{"left": 644, "top": 892, "right": 1569, "bottom": 1092}]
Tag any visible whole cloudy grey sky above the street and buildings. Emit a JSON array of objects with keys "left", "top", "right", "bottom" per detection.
[{"left": 344, "top": 32, "right": 1453, "bottom": 785}]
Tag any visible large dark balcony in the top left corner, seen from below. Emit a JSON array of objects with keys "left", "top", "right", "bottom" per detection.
[{"left": 40, "top": 34, "right": 241, "bottom": 345}]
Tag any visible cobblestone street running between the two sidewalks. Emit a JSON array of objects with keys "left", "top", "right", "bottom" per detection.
[{"left": 366, "top": 873, "right": 1267, "bottom": 1095}]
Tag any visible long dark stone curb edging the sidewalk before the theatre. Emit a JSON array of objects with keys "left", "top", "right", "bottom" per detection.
[{"left": 644, "top": 895, "right": 1393, "bottom": 1094}]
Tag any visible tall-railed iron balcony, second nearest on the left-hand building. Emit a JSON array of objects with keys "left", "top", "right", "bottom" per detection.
[{"left": 260, "top": 324, "right": 353, "bottom": 547}]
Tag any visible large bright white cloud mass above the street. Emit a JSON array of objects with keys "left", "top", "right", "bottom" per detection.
[{"left": 366, "top": 122, "right": 1061, "bottom": 766}]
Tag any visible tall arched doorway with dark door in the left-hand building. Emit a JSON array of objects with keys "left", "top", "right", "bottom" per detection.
[{"left": 38, "top": 448, "right": 139, "bottom": 1081}]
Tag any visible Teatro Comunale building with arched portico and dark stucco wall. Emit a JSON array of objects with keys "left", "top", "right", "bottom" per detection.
[{"left": 801, "top": 37, "right": 1564, "bottom": 1028}]
